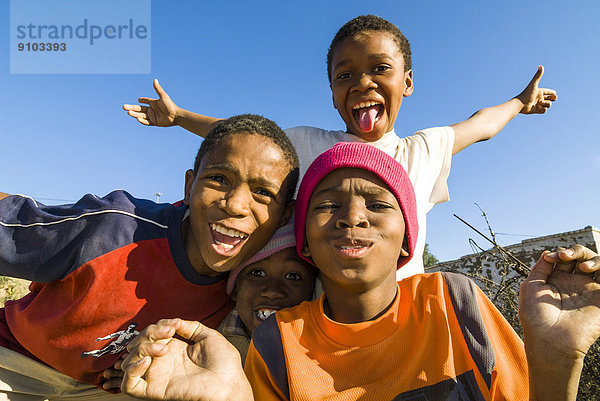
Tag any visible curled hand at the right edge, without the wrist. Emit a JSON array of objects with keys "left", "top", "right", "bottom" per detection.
[{"left": 519, "top": 245, "right": 600, "bottom": 359}]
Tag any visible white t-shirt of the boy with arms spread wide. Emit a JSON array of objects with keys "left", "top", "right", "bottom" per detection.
[{"left": 284, "top": 127, "right": 454, "bottom": 280}]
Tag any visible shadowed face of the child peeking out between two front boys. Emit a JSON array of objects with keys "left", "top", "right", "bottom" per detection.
[{"left": 232, "top": 247, "right": 315, "bottom": 334}]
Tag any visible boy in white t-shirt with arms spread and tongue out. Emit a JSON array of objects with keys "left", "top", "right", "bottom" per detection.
[{"left": 123, "top": 15, "right": 557, "bottom": 279}]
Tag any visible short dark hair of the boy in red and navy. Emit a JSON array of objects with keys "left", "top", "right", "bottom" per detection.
[{"left": 194, "top": 114, "right": 300, "bottom": 204}]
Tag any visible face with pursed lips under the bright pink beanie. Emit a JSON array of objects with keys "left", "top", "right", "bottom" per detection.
[{"left": 303, "top": 168, "right": 404, "bottom": 292}]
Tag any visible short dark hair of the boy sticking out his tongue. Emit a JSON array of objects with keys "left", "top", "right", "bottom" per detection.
[{"left": 327, "top": 15, "right": 412, "bottom": 82}]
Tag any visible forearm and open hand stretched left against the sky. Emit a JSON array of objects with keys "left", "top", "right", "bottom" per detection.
[{"left": 123, "top": 79, "right": 221, "bottom": 138}]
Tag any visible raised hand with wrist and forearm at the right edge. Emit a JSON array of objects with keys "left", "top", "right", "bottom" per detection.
[{"left": 519, "top": 245, "right": 600, "bottom": 400}]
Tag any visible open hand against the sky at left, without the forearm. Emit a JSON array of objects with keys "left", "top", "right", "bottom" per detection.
[{"left": 123, "top": 79, "right": 179, "bottom": 127}]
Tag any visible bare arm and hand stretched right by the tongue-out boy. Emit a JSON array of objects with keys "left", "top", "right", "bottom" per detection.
[{"left": 452, "top": 65, "right": 557, "bottom": 155}]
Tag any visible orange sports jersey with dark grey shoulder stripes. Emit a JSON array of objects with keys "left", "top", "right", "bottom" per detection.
[{"left": 245, "top": 273, "right": 529, "bottom": 401}]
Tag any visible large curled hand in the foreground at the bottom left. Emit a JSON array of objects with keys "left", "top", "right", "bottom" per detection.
[{"left": 121, "top": 319, "right": 253, "bottom": 401}]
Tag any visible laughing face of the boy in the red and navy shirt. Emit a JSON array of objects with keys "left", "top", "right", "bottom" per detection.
[{"left": 182, "top": 134, "right": 291, "bottom": 276}]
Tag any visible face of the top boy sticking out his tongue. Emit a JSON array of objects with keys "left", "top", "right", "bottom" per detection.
[{"left": 331, "top": 31, "right": 413, "bottom": 141}]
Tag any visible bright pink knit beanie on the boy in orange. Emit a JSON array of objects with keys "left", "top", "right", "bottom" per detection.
[{"left": 294, "top": 142, "right": 419, "bottom": 268}]
